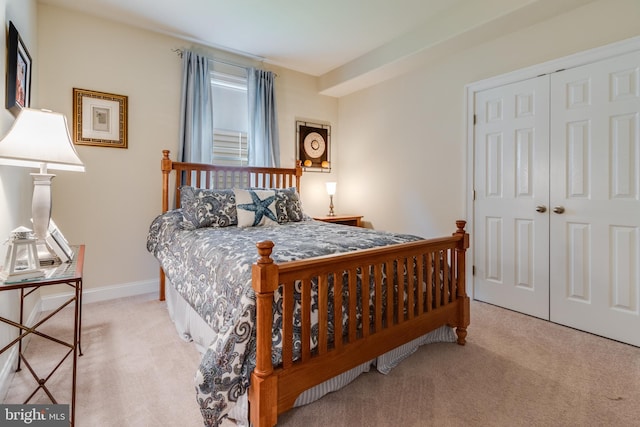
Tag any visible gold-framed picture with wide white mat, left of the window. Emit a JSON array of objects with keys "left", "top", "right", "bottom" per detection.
[{"left": 73, "top": 88, "right": 128, "bottom": 148}]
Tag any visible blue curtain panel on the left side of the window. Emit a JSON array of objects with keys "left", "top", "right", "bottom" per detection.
[{"left": 178, "top": 50, "right": 213, "bottom": 163}]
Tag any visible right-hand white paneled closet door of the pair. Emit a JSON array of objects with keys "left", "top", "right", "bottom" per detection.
[{"left": 550, "top": 53, "right": 640, "bottom": 345}]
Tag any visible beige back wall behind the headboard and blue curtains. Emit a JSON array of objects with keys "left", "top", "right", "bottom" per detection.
[{"left": 38, "top": 4, "right": 337, "bottom": 301}]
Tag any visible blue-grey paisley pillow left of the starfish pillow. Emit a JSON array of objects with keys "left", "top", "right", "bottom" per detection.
[{"left": 180, "top": 186, "right": 238, "bottom": 229}]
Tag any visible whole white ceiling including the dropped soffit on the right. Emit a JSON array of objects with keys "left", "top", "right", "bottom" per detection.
[{"left": 39, "top": 0, "right": 593, "bottom": 96}]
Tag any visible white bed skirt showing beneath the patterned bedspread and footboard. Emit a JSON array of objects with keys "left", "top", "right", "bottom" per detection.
[{"left": 165, "top": 279, "right": 457, "bottom": 426}]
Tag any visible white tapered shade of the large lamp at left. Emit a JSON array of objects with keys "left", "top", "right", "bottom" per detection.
[{"left": 0, "top": 108, "right": 84, "bottom": 172}]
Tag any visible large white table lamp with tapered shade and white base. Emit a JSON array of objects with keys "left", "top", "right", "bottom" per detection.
[{"left": 0, "top": 108, "right": 84, "bottom": 241}]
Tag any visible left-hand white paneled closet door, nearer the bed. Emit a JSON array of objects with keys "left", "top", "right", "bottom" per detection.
[{"left": 473, "top": 76, "right": 549, "bottom": 319}]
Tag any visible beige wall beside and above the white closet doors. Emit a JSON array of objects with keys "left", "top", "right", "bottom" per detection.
[{"left": 336, "top": 0, "right": 640, "bottom": 236}]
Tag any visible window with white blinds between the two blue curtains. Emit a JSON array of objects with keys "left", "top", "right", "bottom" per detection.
[{"left": 210, "top": 61, "right": 249, "bottom": 166}]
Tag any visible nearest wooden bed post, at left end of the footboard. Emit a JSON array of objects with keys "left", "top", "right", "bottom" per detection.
[{"left": 249, "top": 240, "right": 278, "bottom": 427}]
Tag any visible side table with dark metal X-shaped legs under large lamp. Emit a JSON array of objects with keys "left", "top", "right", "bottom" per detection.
[{"left": 0, "top": 245, "right": 84, "bottom": 427}]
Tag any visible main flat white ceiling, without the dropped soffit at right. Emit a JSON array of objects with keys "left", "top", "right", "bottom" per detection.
[{"left": 40, "top": 0, "right": 463, "bottom": 76}]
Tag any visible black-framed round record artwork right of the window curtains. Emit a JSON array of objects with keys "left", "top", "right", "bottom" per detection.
[{"left": 296, "top": 121, "right": 331, "bottom": 172}]
